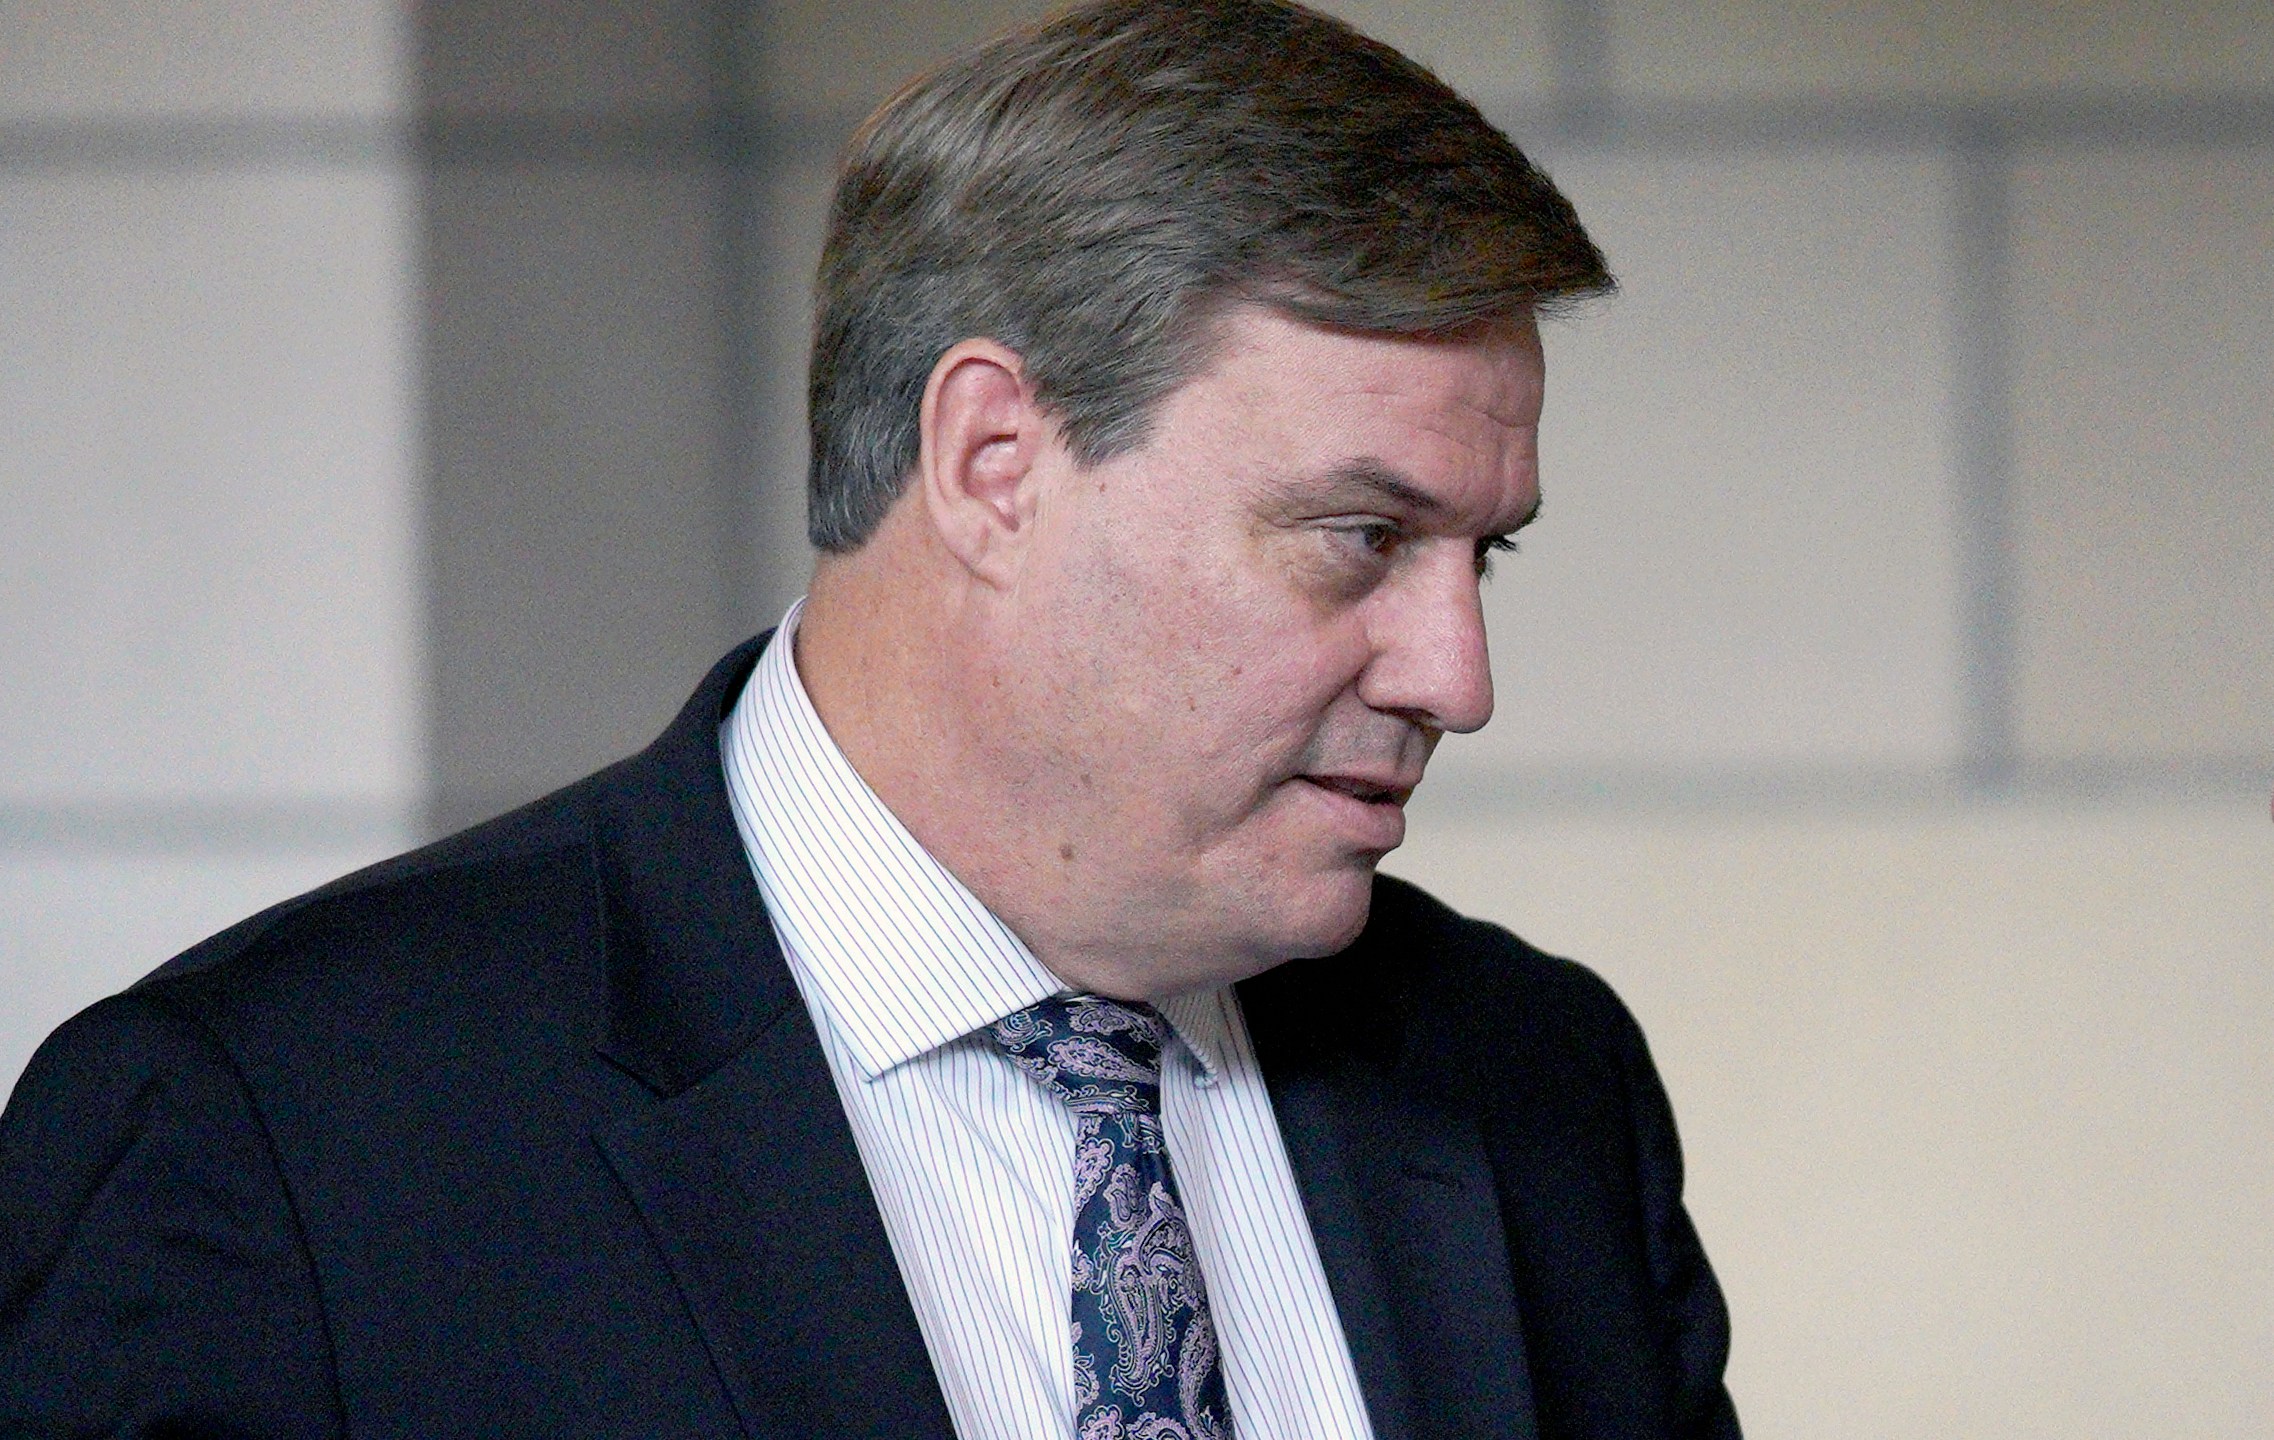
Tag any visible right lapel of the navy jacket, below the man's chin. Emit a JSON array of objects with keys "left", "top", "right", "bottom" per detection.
[{"left": 1242, "top": 946, "right": 1537, "bottom": 1440}]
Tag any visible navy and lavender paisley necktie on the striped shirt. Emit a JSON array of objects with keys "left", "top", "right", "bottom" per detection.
[{"left": 994, "top": 994, "right": 1233, "bottom": 1440}]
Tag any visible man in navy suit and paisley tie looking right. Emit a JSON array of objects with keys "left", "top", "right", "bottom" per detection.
[{"left": 0, "top": 0, "right": 1735, "bottom": 1440}]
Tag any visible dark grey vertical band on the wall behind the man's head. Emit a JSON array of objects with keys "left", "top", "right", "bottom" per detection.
[{"left": 412, "top": 0, "right": 748, "bottom": 830}]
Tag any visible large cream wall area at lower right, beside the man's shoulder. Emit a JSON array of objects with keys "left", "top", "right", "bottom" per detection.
[{"left": 1389, "top": 798, "right": 2274, "bottom": 1440}]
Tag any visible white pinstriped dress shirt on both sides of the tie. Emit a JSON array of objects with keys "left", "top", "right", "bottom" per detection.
[{"left": 721, "top": 607, "right": 1371, "bottom": 1440}]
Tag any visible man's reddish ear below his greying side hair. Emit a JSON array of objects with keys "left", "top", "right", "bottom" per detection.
[{"left": 916, "top": 339, "right": 1051, "bottom": 585}]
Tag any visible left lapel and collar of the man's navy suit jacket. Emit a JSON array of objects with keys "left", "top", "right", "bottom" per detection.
[{"left": 591, "top": 637, "right": 953, "bottom": 1440}]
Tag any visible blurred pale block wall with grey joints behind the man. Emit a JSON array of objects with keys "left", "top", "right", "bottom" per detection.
[{"left": 0, "top": 0, "right": 2274, "bottom": 1440}]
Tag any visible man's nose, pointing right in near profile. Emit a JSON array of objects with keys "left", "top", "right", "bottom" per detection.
[{"left": 1358, "top": 557, "right": 1492, "bottom": 735}]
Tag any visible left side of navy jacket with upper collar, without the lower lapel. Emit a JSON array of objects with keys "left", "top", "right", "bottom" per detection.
[{"left": 0, "top": 644, "right": 794, "bottom": 1435}]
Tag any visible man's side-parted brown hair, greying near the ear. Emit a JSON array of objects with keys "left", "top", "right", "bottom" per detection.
[{"left": 807, "top": 0, "right": 1612, "bottom": 553}]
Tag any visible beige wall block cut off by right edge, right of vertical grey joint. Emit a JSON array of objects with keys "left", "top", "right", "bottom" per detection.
[{"left": 2012, "top": 148, "right": 2274, "bottom": 762}]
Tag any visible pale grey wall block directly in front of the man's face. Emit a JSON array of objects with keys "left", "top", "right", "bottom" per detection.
[{"left": 1439, "top": 152, "right": 1958, "bottom": 773}]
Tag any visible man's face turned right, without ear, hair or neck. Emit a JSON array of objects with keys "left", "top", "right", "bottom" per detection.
[{"left": 996, "top": 307, "right": 1544, "bottom": 994}]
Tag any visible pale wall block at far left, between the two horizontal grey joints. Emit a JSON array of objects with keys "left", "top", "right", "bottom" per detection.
[{"left": 0, "top": 171, "right": 421, "bottom": 803}]
